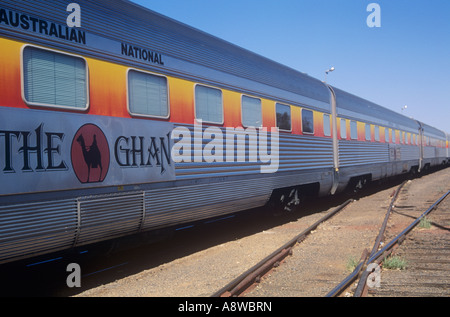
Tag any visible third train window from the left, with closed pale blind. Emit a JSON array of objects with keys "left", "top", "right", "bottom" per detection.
[{"left": 195, "top": 85, "right": 223, "bottom": 124}]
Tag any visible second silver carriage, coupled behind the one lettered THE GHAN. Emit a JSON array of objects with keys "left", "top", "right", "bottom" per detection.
[{"left": 334, "top": 88, "right": 426, "bottom": 190}]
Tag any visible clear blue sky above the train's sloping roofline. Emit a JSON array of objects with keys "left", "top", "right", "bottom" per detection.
[{"left": 133, "top": 0, "right": 450, "bottom": 133}]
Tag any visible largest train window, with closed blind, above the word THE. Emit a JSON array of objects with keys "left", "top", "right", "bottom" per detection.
[{"left": 22, "top": 45, "right": 89, "bottom": 110}]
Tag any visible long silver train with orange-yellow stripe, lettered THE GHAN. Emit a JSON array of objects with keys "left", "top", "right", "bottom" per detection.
[{"left": 0, "top": 0, "right": 450, "bottom": 264}]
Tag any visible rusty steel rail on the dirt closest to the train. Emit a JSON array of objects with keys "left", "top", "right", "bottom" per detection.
[{"left": 211, "top": 199, "right": 353, "bottom": 297}]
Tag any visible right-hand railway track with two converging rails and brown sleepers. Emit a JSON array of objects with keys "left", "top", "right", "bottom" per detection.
[{"left": 327, "top": 184, "right": 450, "bottom": 297}]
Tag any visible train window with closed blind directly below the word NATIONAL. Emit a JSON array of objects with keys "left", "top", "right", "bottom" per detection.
[{"left": 128, "top": 69, "right": 169, "bottom": 118}]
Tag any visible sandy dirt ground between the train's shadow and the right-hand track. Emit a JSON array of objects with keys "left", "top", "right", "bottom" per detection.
[{"left": 76, "top": 168, "right": 450, "bottom": 297}]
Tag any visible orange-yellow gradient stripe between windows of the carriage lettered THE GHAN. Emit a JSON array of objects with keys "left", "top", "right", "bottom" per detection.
[{"left": 0, "top": 38, "right": 344, "bottom": 137}]
